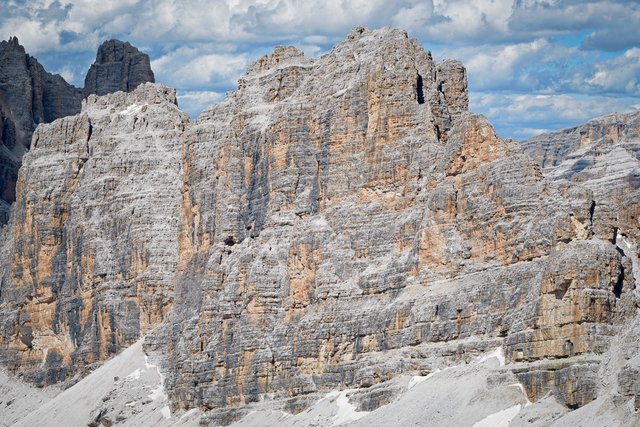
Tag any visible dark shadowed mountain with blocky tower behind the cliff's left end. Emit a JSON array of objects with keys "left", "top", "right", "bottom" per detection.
[{"left": 0, "top": 37, "right": 154, "bottom": 224}]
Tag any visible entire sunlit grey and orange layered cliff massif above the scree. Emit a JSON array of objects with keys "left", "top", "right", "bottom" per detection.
[{"left": 0, "top": 28, "right": 640, "bottom": 425}]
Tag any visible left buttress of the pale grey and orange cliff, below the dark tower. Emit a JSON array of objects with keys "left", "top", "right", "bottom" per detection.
[{"left": 0, "top": 84, "right": 188, "bottom": 385}]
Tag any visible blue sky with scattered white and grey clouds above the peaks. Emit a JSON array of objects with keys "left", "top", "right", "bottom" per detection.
[{"left": 0, "top": 0, "right": 640, "bottom": 139}]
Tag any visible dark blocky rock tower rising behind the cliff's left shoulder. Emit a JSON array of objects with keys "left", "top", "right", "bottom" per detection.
[{"left": 83, "top": 40, "right": 155, "bottom": 96}]
